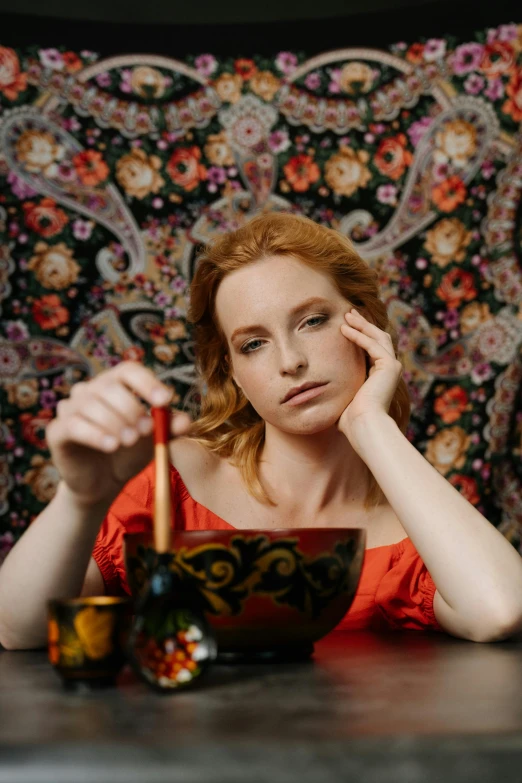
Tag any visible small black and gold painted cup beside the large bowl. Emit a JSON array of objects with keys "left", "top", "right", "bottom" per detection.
[{"left": 48, "top": 595, "right": 132, "bottom": 689}]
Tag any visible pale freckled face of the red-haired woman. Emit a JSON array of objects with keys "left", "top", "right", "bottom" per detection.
[{"left": 216, "top": 256, "right": 366, "bottom": 435}]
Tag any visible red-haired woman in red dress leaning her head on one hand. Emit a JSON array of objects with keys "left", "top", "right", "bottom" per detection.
[{"left": 0, "top": 213, "right": 522, "bottom": 648}]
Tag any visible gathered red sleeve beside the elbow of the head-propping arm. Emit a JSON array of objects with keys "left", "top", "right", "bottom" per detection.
[{"left": 375, "top": 538, "right": 443, "bottom": 632}]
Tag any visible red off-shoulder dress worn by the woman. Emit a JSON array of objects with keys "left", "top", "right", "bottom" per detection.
[{"left": 92, "top": 462, "right": 443, "bottom": 631}]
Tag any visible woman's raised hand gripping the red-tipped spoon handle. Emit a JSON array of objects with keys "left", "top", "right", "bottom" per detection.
[{"left": 46, "top": 362, "right": 191, "bottom": 506}]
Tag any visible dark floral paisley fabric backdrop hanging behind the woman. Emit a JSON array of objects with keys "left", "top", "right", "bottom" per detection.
[{"left": 0, "top": 23, "right": 522, "bottom": 561}]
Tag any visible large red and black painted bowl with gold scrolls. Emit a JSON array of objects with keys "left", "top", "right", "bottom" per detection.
[{"left": 124, "top": 528, "right": 366, "bottom": 660}]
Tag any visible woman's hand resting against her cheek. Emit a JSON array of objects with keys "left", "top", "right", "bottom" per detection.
[{"left": 337, "top": 309, "right": 402, "bottom": 440}]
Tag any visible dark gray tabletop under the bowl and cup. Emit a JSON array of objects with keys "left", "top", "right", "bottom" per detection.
[{"left": 0, "top": 632, "right": 522, "bottom": 783}]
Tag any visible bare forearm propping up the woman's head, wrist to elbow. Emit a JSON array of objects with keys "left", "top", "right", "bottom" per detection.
[{"left": 345, "top": 411, "right": 522, "bottom": 642}]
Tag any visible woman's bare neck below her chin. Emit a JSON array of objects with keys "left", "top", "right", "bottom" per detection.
[{"left": 260, "top": 424, "right": 370, "bottom": 516}]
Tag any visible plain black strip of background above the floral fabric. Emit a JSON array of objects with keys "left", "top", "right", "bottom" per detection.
[{"left": 0, "top": 0, "right": 521, "bottom": 57}]
